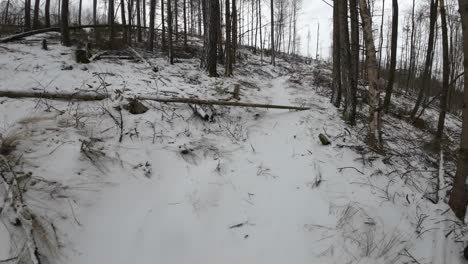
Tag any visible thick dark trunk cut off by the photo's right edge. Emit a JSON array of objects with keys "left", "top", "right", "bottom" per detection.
[{"left": 449, "top": 0, "right": 468, "bottom": 221}]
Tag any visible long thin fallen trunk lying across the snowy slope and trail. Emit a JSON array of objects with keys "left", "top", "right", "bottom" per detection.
[{"left": 0, "top": 91, "right": 310, "bottom": 111}]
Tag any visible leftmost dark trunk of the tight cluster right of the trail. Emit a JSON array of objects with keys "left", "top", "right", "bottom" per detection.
[{"left": 331, "top": 0, "right": 342, "bottom": 107}]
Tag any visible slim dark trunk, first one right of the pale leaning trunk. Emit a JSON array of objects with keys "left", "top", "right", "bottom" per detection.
[{"left": 383, "top": 0, "right": 399, "bottom": 112}]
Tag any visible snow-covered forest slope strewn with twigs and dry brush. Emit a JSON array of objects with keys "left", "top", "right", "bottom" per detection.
[{"left": 0, "top": 35, "right": 466, "bottom": 264}]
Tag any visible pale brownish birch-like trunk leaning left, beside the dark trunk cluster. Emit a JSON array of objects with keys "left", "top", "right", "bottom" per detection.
[{"left": 359, "top": 0, "right": 383, "bottom": 150}]
